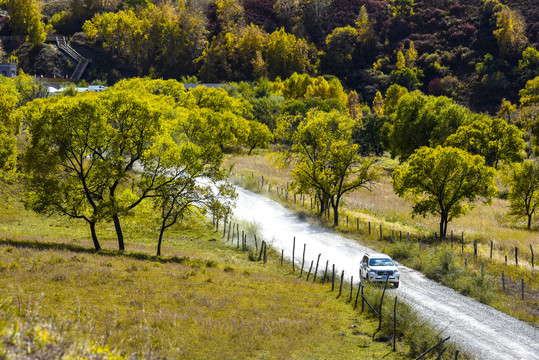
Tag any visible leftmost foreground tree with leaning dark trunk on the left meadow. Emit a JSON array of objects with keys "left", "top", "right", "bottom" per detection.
[{"left": 21, "top": 94, "right": 111, "bottom": 250}]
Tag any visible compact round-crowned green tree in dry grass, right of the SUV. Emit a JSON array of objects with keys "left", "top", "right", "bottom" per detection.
[{"left": 392, "top": 146, "right": 496, "bottom": 238}]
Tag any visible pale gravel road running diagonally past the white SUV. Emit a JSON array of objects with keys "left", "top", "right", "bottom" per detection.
[{"left": 234, "top": 188, "right": 539, "bottom": 360}]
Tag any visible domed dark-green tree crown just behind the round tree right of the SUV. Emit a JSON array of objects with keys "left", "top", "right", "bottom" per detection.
[{"left": 445, "top": 115, "right": 524, "bottom": 169}]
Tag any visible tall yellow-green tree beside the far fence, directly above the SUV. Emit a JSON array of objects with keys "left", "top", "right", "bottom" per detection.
[{"left": 281, "top": 110, "right": 379, "bottom": 226}]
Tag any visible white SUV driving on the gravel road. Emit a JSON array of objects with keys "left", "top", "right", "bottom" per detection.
[{"left": 359, "top": 254, "right": 400, "bottom": 288}]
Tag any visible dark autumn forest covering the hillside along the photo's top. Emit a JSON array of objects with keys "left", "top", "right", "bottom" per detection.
[{"left": 0, "top": 0, "right": 539, "bottom": 114}]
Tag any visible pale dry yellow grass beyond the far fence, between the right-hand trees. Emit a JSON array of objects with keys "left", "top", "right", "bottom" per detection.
[{"left": 226, "top": 153, "right": 539, "bottom": 256}]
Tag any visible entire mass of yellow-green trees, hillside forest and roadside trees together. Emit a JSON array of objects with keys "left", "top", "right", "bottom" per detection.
[{"left": 0, "top": 0, "right": 539, "bottom": 245}]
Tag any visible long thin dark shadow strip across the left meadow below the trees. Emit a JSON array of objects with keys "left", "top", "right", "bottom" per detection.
[{"left": 0, "top": 235, "right": 215, "bottom": 267}]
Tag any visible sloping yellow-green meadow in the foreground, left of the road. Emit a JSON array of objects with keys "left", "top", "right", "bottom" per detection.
[{"left": 0, "top": 181, "right": 422, "bottom": 359}]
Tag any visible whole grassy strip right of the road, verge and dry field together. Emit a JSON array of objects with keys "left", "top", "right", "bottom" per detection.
[{"left": 226, "top": 152, "right": 539, "bottom": 326}]
